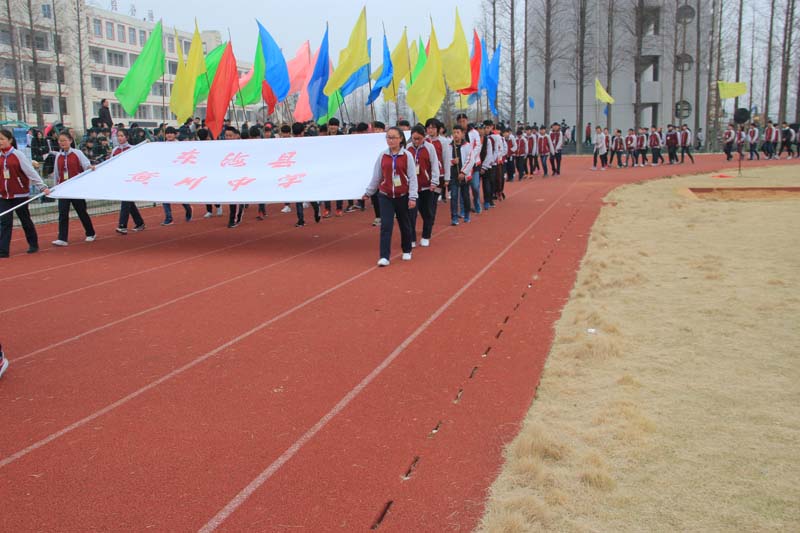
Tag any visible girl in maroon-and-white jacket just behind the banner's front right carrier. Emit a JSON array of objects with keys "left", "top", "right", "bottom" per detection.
[{"left": 408, "top": 124, "right": 441, "bottom": 248}]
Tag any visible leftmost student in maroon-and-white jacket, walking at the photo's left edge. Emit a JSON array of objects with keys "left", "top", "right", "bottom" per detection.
[{"left": 0, "top": 129, "right": 50, "bottom": 256}]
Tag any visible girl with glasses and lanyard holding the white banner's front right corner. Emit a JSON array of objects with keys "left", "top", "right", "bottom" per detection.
[{"left": 363, "top": 127, "right": 417, "bottom": 267}]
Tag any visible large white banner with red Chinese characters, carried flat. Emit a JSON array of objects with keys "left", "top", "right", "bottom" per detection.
[{"left": 50, "top": 133, "right": 386, "bottom": 204}]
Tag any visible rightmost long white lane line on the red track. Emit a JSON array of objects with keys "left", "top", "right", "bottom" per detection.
[{"left": 197, "top": 179, "right": 578, "bottom": 533}]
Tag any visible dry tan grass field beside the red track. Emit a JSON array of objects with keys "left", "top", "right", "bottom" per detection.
[{"left": 480, "top": 166, "right": 800, "bottom": 533}]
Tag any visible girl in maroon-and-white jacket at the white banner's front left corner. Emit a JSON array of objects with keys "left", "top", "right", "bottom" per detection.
[{"left": 53, "top": 131, "right": 96, "bottom": 246}]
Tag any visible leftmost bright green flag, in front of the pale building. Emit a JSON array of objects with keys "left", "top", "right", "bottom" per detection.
[{"left": 114, "top": 21, "right": 164, "bottom": 116}]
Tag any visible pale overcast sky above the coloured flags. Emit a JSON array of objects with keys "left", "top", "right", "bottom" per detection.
[{"left": 90, "top": 0, "right": 480, "bottom": 65}]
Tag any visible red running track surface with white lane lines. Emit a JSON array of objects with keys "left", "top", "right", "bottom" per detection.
[{"left": 0, "top": 156, "right": 785, "bottom": 532}]
